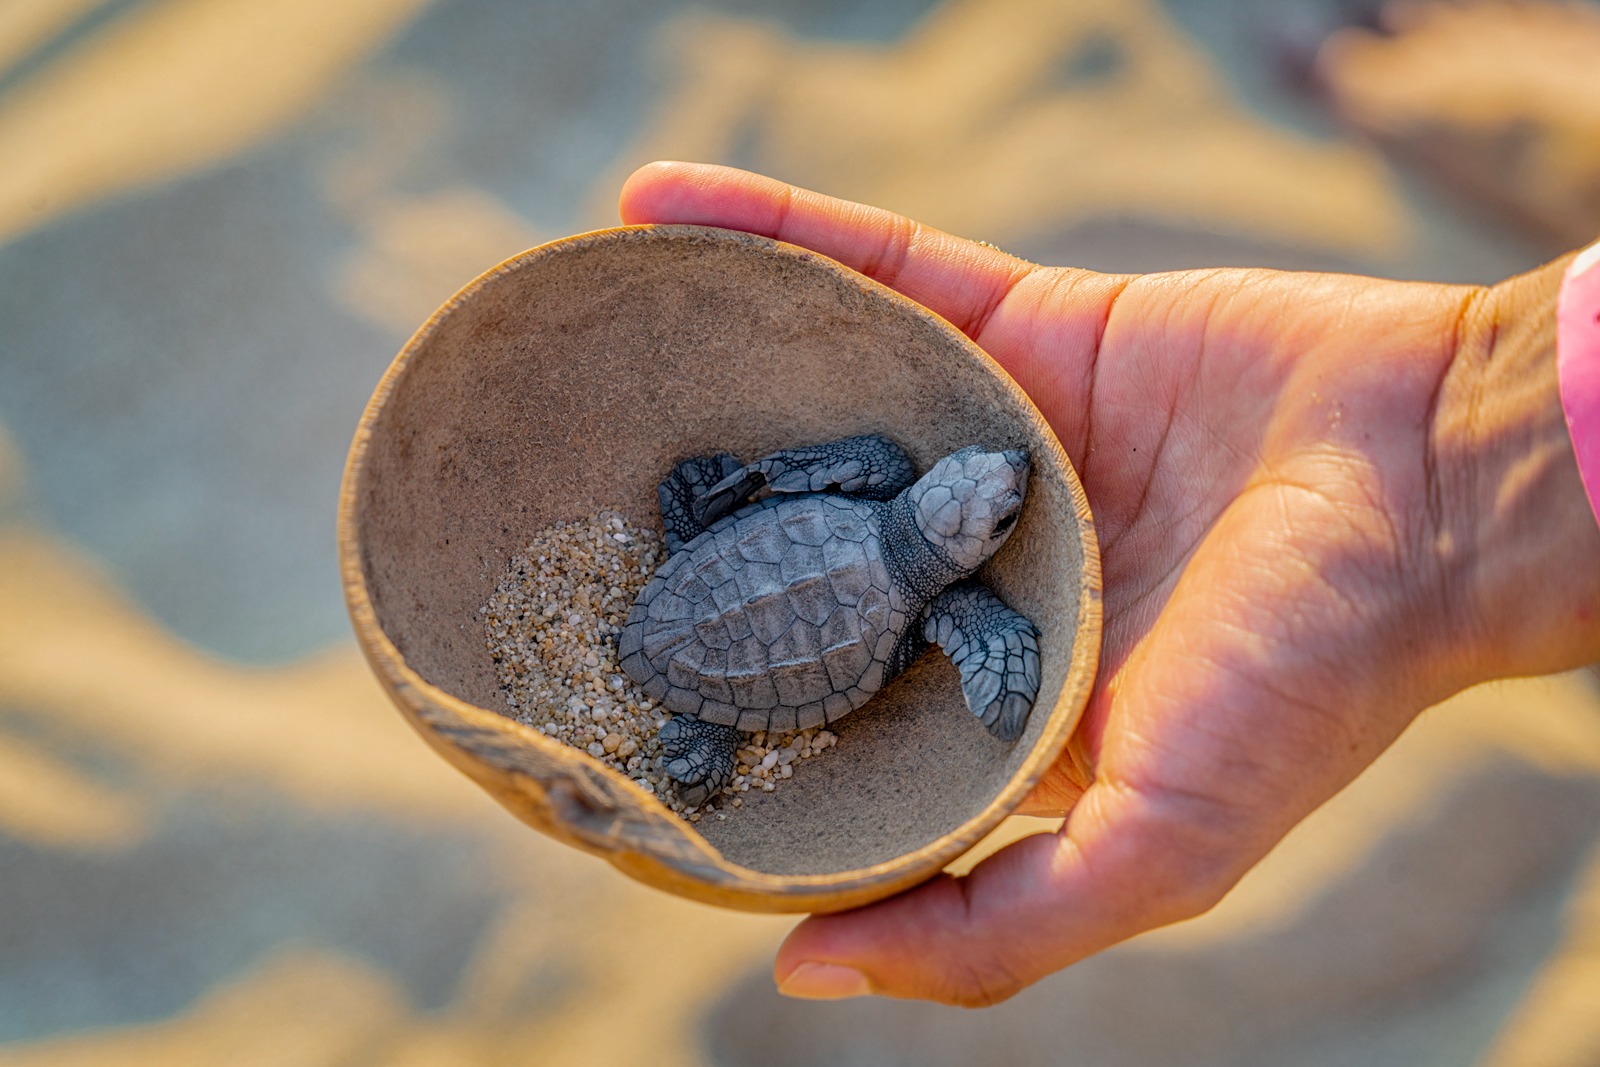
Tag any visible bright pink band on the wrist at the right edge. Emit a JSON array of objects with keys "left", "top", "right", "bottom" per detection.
[{"left": 1555, "top": 243, "right": 1600, "bottom": 520}]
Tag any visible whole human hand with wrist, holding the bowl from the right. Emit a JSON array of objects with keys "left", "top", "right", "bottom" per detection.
[{"left": 621, "top": 163, "right": 1600, "bottom": 1005}]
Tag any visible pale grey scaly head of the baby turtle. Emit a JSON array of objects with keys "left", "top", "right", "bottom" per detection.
[{"left": 906, "top": 445, "right": 1027, "bottom": 574}]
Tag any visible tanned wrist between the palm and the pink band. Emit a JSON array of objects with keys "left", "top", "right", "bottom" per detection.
[{"left": 1434, "top": 259, "right": 1600, "bottom": 685}]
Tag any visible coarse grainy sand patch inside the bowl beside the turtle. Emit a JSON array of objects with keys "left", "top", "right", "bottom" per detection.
[{"left": 482, "top": 510, "right": 837, "bottom": 822}]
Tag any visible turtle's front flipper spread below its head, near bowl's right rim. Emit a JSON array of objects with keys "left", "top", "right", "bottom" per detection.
[{"left": 923, "top": 581, "right": 1038, "bottom": 741}]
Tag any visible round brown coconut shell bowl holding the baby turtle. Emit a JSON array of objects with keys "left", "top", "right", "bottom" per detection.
[{"left": 339, "top": 226, "right": 1101, "bottom": 912}]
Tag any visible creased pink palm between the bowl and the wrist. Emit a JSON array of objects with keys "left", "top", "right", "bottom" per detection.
[{"left": 998, "top": 272, "right": 1451, "bottom": 870}]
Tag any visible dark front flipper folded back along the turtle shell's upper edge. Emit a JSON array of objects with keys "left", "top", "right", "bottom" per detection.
[{"left": 699, "top": 434, "right": 917, "bottom": 526}]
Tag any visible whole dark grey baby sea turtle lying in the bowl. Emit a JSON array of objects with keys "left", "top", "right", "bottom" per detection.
[{"left": 618, "top": 435, "right": 1038, "bottom": 808}]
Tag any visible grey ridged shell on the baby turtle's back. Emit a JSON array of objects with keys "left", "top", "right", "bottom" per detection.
[{"left": 618, "top": 494, "right": 912, "bottom": 731}]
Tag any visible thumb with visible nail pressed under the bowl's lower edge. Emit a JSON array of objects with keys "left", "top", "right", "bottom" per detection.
[{"left": 774, "top": 782, "right": 1254, "bottom": 1006}]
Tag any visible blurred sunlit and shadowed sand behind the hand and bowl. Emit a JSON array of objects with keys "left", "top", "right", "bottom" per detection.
[{"left": 0, "top": 0, "right": 1600, "bottom": 1067}]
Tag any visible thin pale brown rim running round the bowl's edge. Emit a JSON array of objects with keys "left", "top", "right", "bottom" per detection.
[{"left": 338, "top": 224, "right": 1102, "bottom": 912}]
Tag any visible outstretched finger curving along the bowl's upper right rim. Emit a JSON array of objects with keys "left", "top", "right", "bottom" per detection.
[{"left": 619, "top": 163, "right": 1130, "bottom": 461}]
